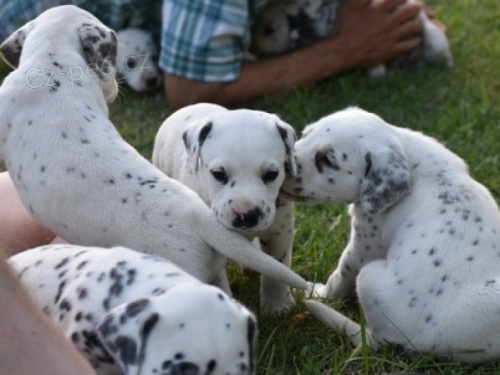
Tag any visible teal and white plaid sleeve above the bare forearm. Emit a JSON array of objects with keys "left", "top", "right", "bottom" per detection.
[{"left": 160, "top": 0, "right": 265, "bottom": 82}]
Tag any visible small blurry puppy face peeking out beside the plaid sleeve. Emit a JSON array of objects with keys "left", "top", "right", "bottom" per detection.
[{"left": 116, "top": 27, "right": 162, "bottom": 92}]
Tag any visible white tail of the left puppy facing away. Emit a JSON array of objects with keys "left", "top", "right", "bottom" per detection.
[{"left": 199, "top": 215, "right": 308, "bottom": 290}]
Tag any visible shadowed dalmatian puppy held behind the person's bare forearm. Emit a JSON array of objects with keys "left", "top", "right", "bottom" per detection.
[{"left": 251, "top": 0, "right": 453, "bottom": 78}]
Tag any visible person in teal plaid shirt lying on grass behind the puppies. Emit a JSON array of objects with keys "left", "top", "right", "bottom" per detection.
[{"left": 0, "top": 0, "right": 438, "bottom": 109}]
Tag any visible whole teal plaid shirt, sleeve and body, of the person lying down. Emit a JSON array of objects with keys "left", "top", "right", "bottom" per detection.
[{"left": 0, "top": 0, "right": 267, "bottom": 82}]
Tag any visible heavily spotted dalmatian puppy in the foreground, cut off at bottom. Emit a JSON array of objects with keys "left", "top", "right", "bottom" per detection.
[{"left": 9, "top": 244, "right": 257, "bottom": 375}]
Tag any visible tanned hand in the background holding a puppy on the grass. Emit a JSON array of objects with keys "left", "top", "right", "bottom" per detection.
[{"left": 333, "top": 0, "right": 423, "bottom": 68}]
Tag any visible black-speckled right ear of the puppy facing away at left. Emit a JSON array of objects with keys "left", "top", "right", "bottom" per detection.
[{"left": 77, "top": 23, "right": 117, "bottom": 77}]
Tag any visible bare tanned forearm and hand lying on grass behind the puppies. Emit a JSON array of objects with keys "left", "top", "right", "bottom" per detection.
[{"left": 165, "top": 0, "right": 422, "bottom": 108}]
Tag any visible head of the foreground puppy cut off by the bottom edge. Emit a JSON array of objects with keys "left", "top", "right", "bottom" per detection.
[{"left": 98, "top": 283, "right": 257, "bottom": 375}]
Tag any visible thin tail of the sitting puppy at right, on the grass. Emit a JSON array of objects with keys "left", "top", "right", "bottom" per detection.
[{"left": 304, "top": 299, "right": 372, "bottom": 347}]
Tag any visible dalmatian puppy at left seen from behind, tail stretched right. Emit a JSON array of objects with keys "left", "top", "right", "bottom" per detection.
[{"left": 0, "top": 6, "right": 307, "bottom": 293}]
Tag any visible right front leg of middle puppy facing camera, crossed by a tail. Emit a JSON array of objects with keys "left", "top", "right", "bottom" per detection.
[{"left": 260, "top": 199, "right": 295, "bottom": 314}]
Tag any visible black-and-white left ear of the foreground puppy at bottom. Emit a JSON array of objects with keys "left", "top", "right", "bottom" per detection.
[{"left": 97, "top": 298, "right": 160, "bottom": 374}]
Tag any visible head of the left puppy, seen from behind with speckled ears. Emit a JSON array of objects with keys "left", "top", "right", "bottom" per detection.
[{"left": 0, "top": 5, "right": 118, "bottom": 103}]
